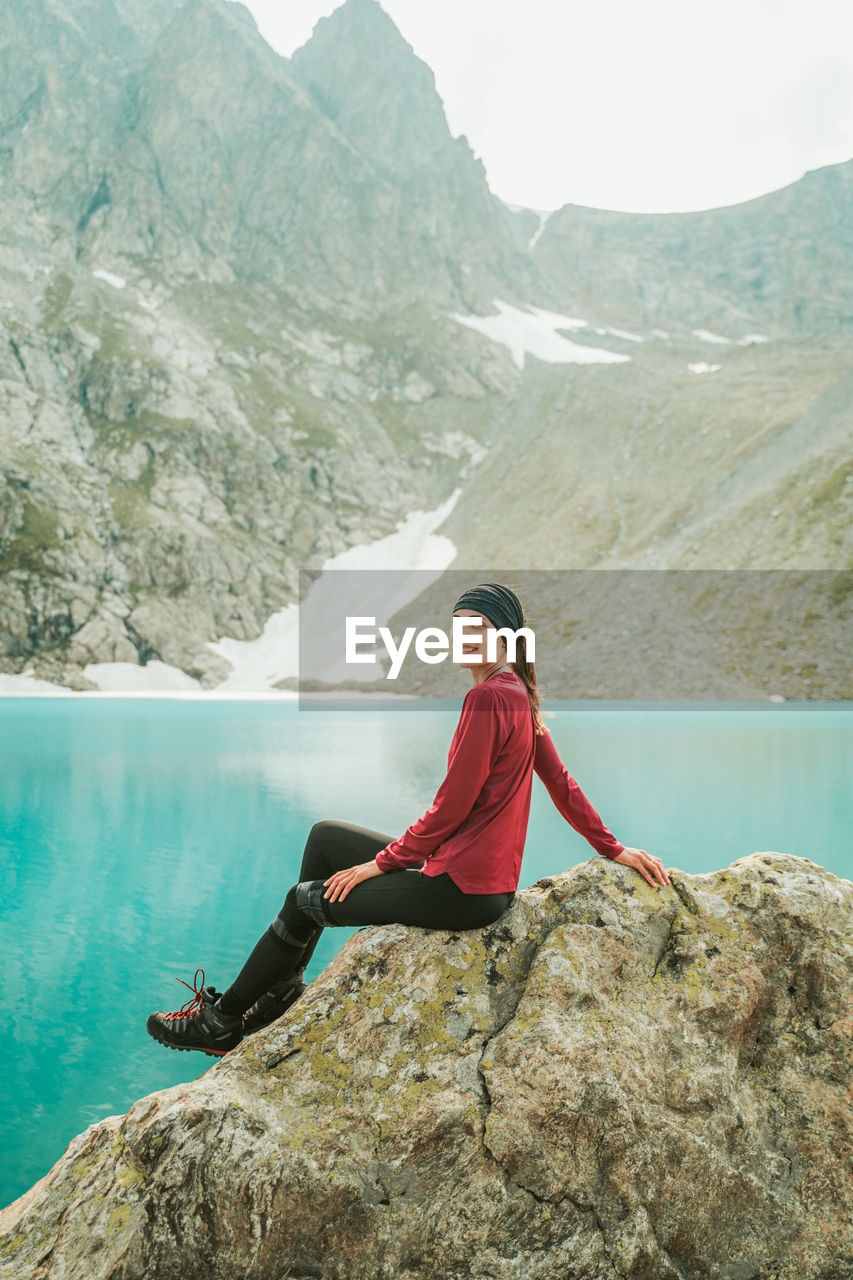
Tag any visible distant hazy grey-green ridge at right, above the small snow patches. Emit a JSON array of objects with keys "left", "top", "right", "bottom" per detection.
[{"left": 532, "top": 163, "right": 853, "bottom": 338}]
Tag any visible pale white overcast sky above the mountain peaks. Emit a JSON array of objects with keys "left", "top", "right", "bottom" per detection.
[{"left": 235, "top": 0, "right": 853, "bottom": 212}]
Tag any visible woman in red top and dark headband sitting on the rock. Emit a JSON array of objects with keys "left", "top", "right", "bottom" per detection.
[{"left": 146, "top": 582, "right": 670, "bottom": 1056}]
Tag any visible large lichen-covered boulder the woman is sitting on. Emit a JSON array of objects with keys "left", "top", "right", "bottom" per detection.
[{"left": 0, "top": 852, "right": 853, "bottom": 1280}]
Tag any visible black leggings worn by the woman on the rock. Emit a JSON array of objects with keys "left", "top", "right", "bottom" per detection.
[{"left": 222, "top": 819, "right": 515, "bottom": 1014}]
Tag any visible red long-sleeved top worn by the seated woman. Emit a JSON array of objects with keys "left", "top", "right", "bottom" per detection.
[{"left": 377, "top": 669, "right": 625, "bottom": 893}]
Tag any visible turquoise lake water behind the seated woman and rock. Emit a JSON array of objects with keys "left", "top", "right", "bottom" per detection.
[{"left": 0, "top": 698, "right": 853, "bottom": 1206}]
